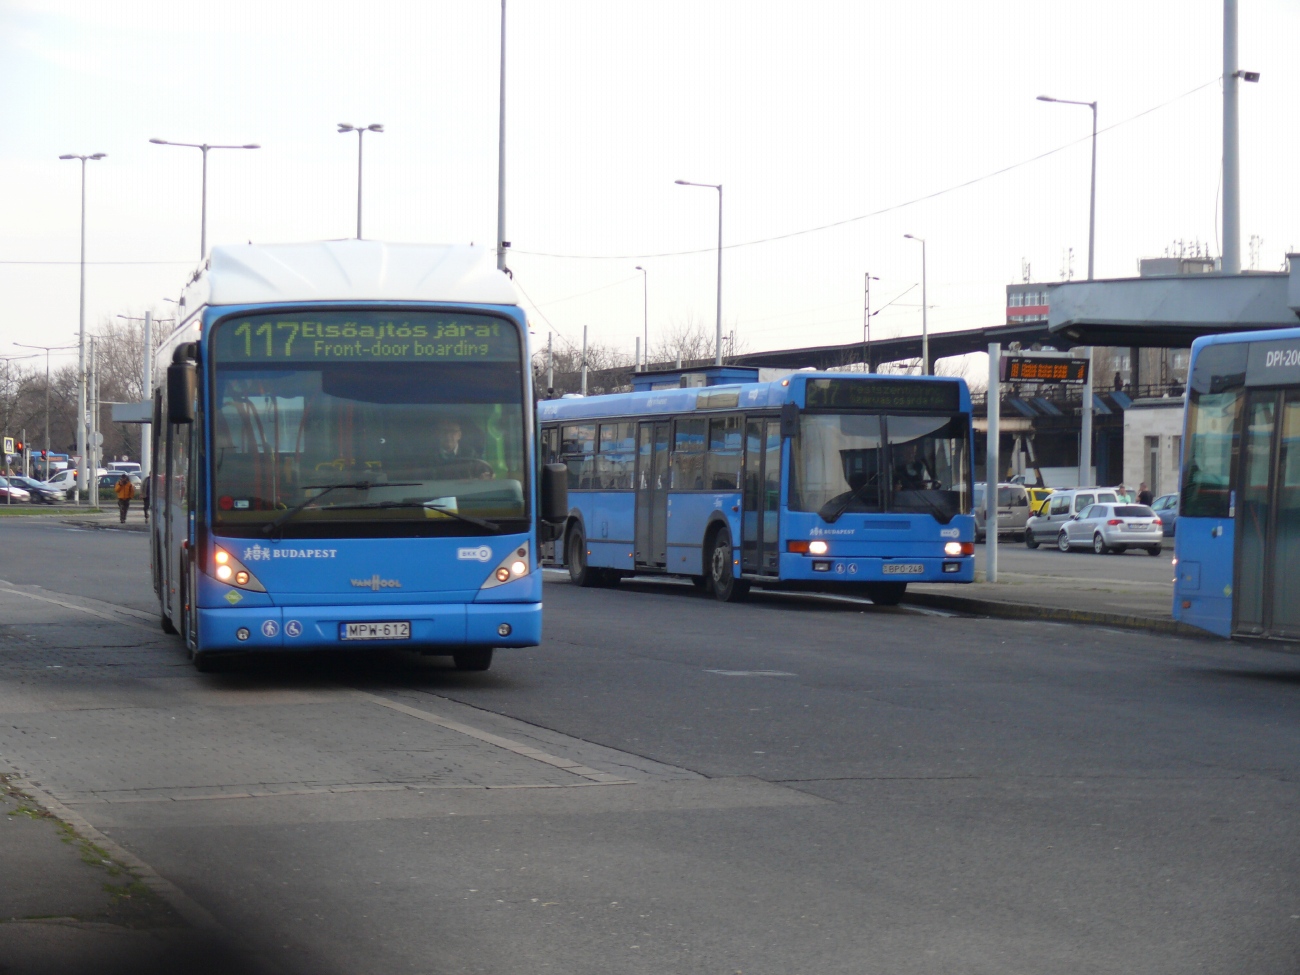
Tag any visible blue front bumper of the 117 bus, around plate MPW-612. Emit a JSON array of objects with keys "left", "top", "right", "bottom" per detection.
[{"left": 199, "top": 602, "right": 542, "bottom": 653}]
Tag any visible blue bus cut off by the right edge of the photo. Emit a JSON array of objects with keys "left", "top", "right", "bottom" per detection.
[{"left": 1174, "top": 329, "right": 1300, "bottom": 649}]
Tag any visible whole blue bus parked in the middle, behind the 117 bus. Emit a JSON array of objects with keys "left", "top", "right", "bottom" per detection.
[{"left": 537, "top": 371, "right": 975, "bottom": 603}]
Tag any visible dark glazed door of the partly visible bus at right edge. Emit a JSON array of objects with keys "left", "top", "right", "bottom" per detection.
[{"left": 1232, "top": 389, "right": 1300, "bottom": 640}]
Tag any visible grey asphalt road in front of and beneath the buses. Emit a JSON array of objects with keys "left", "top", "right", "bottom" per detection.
[{"left": 0, "top": 514, "right": 1300, "bottom": 975}]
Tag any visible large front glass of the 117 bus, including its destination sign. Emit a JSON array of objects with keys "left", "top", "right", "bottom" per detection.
[{"left": 209, "top": 309, "right": 528, "bottom": 537}]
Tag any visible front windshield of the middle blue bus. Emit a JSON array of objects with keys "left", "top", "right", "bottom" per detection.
[{"left": 790, "top": 413, "right": 970, "bottom": 524}]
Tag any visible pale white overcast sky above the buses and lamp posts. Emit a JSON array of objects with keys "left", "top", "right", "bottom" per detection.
[{"left": 0, "top": 0, "right": 1300, "bottom": 374}]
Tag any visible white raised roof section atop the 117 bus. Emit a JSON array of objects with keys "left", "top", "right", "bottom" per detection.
[{"left": 185, "top": 241, "right": 519, "bottom": 312}]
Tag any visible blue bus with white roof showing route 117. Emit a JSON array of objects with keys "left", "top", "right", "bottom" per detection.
[{"left": 150, "top": 241, "right": 567, "bottom": 671}]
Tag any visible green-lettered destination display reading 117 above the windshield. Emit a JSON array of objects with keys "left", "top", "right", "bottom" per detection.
[{"left": 213, "top": 309, "right": 520, "bottom": 364}]
